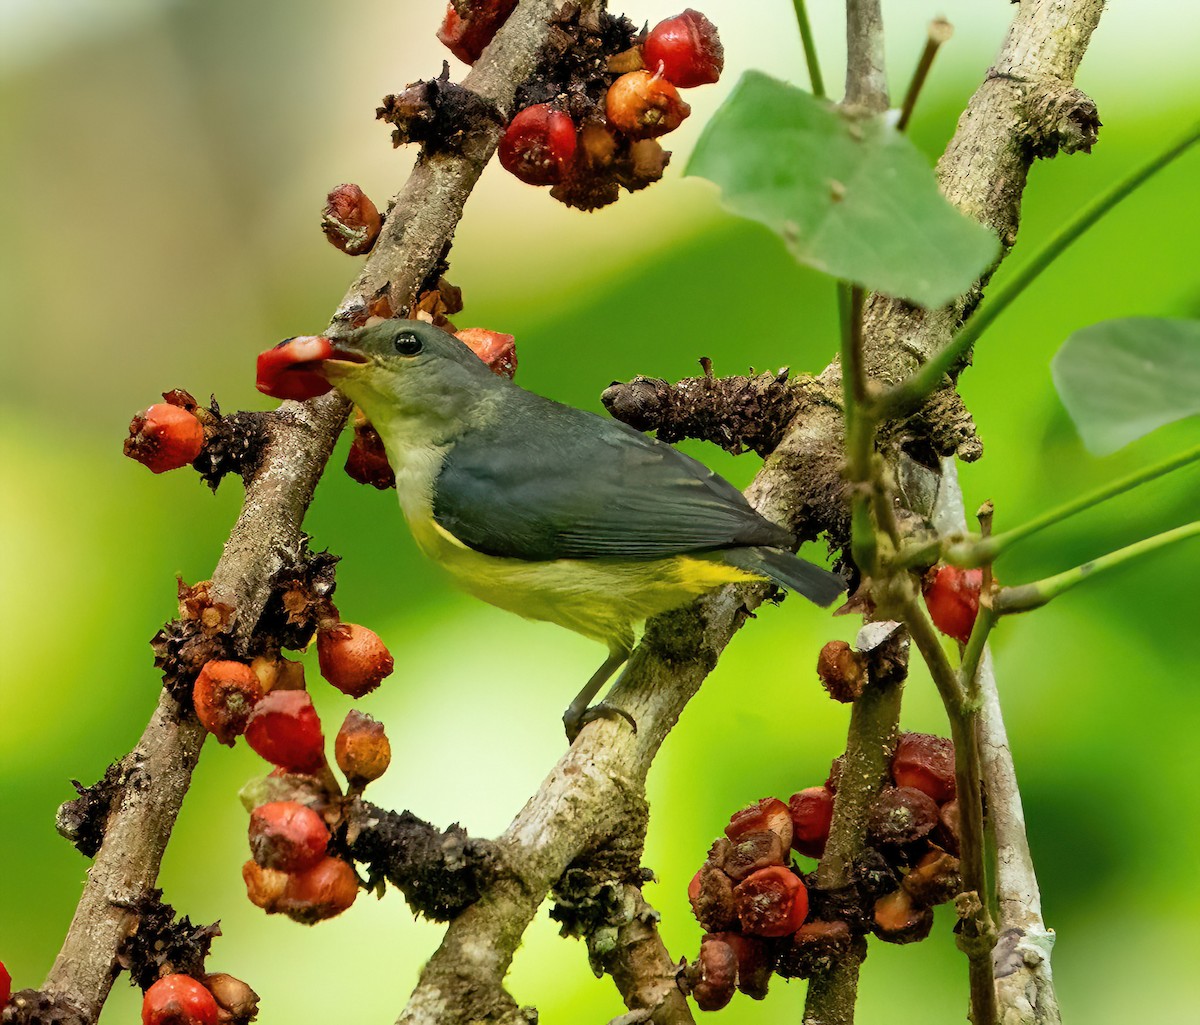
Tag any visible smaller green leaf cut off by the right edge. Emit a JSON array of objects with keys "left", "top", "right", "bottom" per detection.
[{"left": 1050, "top": 317, "right": 1200, "bottom": 456}]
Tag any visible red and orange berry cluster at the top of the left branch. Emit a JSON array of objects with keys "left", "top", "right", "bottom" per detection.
[{"left": 438, "top": 0, "right": 725, "bottom": 210}]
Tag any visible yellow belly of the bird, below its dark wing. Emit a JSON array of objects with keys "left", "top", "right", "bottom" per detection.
[{"left": 409, "top": 517, "right": 761, "bottom": 652}]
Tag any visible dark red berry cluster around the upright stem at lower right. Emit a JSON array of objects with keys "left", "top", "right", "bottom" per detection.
[{"left": 685, "top": 733, "right": 960, "bottom": 1011}]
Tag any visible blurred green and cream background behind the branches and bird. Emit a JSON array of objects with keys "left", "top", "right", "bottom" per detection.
[{"left": 0, "top": 0, "right": 1200, "bottom": 1025}]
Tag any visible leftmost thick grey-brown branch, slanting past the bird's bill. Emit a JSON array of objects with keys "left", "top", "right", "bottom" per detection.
[{"left": 39, "top": 0, "right": 573, "bottom": 1021}]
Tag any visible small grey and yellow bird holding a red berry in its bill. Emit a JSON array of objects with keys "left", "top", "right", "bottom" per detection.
[{"left": 314, "top": 319, "right": 846, "bottom": 738}]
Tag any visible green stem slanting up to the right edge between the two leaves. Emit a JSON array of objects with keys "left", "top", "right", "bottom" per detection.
[{"left": 881, "top": 116, "right": 1200, "bottom": 419}]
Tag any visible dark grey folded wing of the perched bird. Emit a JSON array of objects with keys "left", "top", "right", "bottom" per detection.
[{"left": 433, "top": 389, "right": 792, "bottom": 562}]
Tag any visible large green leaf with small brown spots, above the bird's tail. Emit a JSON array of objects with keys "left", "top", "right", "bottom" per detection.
[{"left": 686, "top": 71, "right": 1000, "bottom": 306}]
